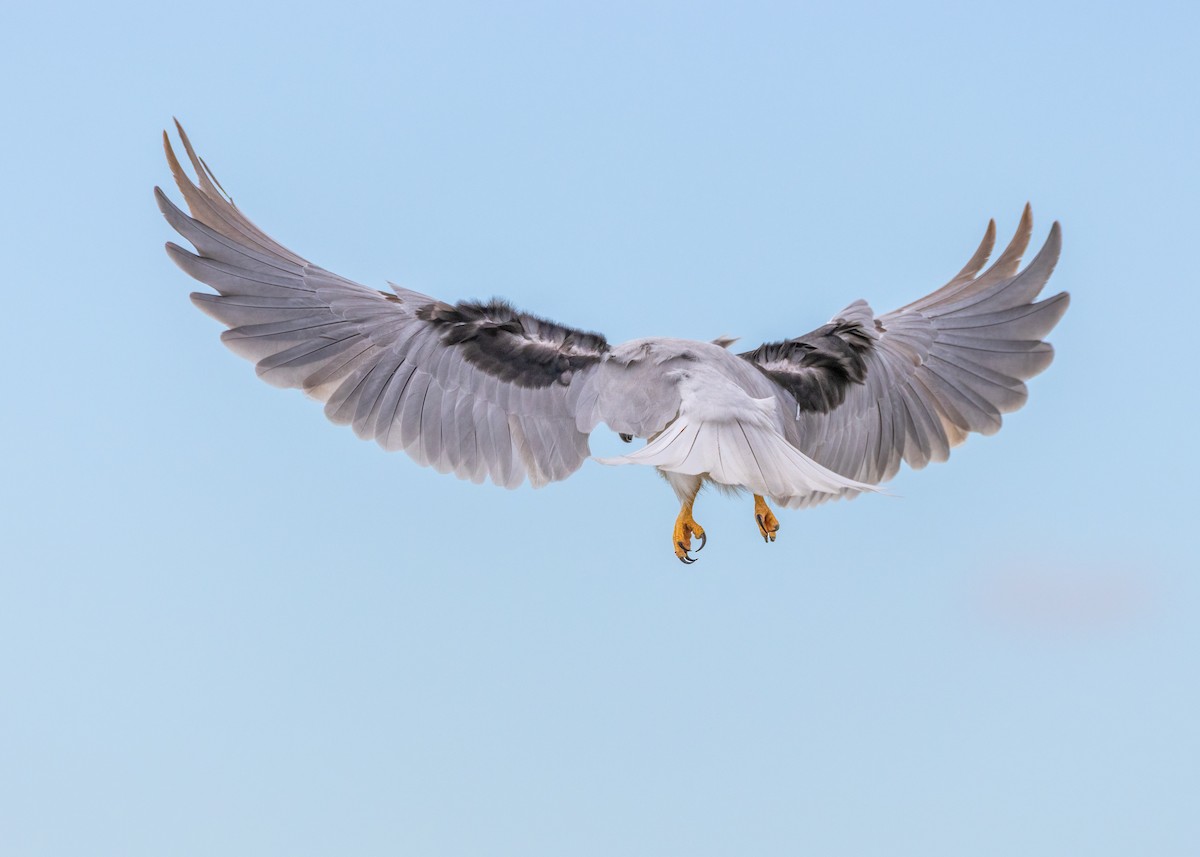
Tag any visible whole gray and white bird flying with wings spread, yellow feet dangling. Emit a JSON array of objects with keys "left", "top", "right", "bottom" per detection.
[{"left": 155, "top": 120, "right": 1070, "bottom": 564}]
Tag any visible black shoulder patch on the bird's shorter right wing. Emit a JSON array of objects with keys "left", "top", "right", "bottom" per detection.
[{"left": 738, "top": 319, "right": 876, "bottom": 413}]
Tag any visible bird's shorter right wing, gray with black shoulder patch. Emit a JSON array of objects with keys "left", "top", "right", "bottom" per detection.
[{"left": 742, "top": 205, "right": 1069, "bottom": 501}]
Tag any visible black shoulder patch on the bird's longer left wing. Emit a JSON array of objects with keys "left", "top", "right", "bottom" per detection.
[{"left": 415, "top": 299, "right": 610, "bottom": 388}]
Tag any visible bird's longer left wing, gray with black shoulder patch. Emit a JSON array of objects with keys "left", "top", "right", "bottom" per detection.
[{"left": 155, "top": 122, "right": 608, "bottom": 487}]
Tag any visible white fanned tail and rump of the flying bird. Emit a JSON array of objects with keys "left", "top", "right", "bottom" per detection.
[{"left": 598, "top": 364, "right": 878, "bottom": 507}]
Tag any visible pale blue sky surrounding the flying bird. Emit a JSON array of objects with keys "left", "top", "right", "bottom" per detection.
[{"left": 0, "top": 2, "right": 1200, "bottom": 857}]
